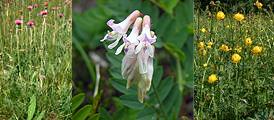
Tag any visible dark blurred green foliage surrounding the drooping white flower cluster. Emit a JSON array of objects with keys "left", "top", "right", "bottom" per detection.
[{"left": 72, "top": 0, "right": 193, "bottom": 120}]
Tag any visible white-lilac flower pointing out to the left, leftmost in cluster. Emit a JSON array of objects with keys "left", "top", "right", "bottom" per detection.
[{"left": 100, "top": 10, "right": 140, "bottom": 49}]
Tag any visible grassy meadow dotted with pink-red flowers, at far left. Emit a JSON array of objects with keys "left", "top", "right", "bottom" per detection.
[{"left": 0, "top": 0, "right": 72, "bottom": 120}]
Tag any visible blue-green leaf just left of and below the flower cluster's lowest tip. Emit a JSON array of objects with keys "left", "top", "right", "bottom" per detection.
[{"left": 120, "top": 95, "right": 144, "bottom": 109}]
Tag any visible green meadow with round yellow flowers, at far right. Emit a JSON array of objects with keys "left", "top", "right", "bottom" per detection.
[{"left": 194, "top": 7, "right": 274, "bottom": 120}]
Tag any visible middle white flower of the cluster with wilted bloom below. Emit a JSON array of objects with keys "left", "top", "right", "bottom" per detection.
[{"left": 122, "top": 18, "right": 142, "bottom": 88}]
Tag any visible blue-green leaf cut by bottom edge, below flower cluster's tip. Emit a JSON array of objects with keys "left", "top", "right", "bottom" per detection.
[{"left": 137, "top": 108, "right": 156, "bottom": 120}]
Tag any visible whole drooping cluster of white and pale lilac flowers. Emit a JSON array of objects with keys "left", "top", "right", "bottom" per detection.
[{"left": 101, "top": 10, "right": 157, "bottom": 102}]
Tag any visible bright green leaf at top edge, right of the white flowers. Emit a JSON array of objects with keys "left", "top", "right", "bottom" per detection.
[{"left": 151, "top": 0, "right": 179, "bottom": 14}]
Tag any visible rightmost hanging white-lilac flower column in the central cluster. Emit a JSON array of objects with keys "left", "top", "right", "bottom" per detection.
[{"left": 135, "top": 15, "right": 157, "bottom": 102}]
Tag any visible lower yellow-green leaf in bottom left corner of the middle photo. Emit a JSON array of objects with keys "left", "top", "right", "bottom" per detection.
[{"left": 72, "top": 105, "right": 92, "bottom": 120}]
